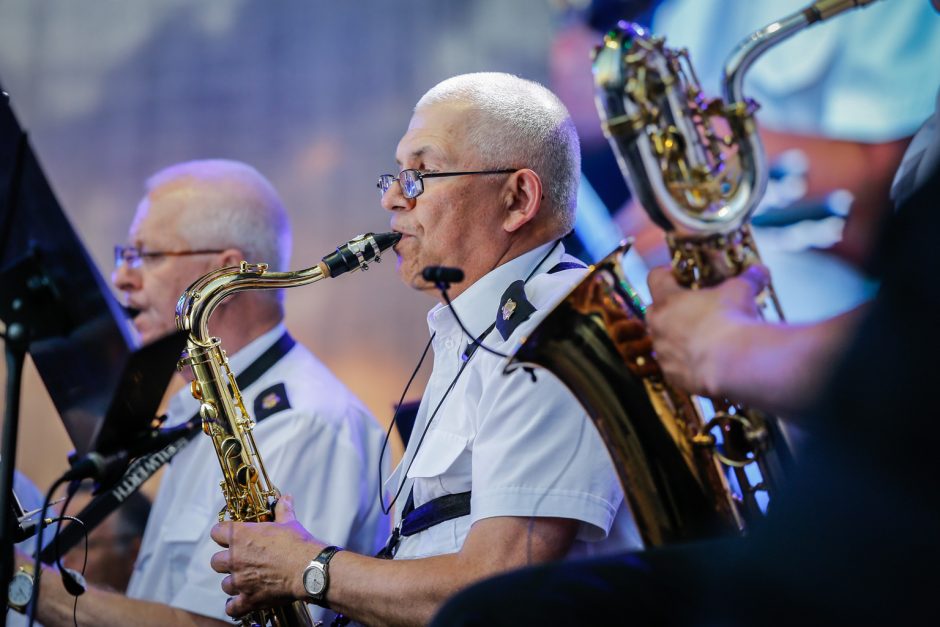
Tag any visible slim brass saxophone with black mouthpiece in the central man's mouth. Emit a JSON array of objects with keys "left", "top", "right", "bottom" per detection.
[{"left": 176, "top": 233, "right": 401, "bottom": 627}]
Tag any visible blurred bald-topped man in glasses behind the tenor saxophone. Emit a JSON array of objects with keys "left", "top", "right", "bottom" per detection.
[{"left": 14, "top": 160, "right": 389, "bottom": 627}]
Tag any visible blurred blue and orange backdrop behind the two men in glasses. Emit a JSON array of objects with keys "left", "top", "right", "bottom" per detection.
[{"left": 0, "top": 0, "right": 620, "bottom": 500}]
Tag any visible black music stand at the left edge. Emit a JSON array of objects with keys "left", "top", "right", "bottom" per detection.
[{"left": 0, "top": 79, "right": 184, "bottom": 625}]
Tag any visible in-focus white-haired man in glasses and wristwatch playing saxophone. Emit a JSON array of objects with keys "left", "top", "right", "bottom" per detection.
[{"left": 212, "top": 73, "right": 639, "bottom": 624}]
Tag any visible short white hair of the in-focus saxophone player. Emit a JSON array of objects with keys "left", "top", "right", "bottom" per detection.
[{"left": 415, "top": 72, "right": 581, "bottom": 235}]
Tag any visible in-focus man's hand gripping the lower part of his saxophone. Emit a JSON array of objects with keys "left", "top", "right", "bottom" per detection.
[{"left": 210, "top": 495, "right": 324, "bottom": 618}]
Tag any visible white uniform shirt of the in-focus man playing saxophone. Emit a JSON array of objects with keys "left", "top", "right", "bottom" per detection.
[{"left": 386, "top": 245, "right": 641, "bottom": 559}]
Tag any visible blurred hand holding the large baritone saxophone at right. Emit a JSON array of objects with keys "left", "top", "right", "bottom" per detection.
[{"left": 646, "top": 265, "right": 770, "bottom": 396}]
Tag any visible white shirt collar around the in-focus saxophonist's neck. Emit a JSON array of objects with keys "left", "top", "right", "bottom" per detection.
[{"left": 428, "top": 242, "right": 565, "bottom": 337}]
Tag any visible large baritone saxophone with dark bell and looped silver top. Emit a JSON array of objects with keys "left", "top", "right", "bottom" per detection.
[{"left": 507, "top": 0, "right": 874, "bottom": 546}]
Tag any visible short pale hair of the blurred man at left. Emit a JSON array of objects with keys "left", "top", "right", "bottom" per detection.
[{"left": 146, "top": 159, "right": 291, "bottom": 301}]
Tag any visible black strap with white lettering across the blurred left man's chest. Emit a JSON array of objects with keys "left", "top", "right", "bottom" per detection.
[{"left": 40, "top": 331, "right": 297, "bottom": 564}]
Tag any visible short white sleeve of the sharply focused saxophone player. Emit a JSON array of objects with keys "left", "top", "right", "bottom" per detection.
[{"left": 471, "top": 355, "right": 623, "bottom": 541}]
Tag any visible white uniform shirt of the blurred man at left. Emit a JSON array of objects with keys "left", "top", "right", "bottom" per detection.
[{"left": 127, "top": 325, "right": 389, "bottom": 621}]
